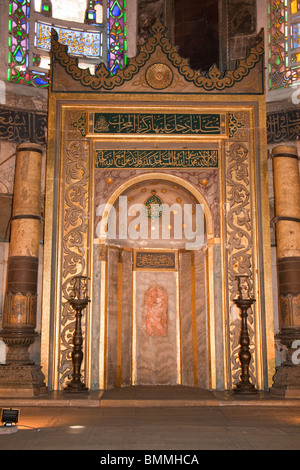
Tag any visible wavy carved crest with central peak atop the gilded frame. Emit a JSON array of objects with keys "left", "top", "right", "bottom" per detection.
[{"left": 51, "top": 21, "right": 264, "bottom": 93}]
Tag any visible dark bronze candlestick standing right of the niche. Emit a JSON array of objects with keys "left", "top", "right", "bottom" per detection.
[{"left": 233, "top": 276, "right": 257, "bottom": 394}]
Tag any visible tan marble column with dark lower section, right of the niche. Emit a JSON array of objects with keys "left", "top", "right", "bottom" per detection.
[{"left": 271, "top": 145, "right": 300, "bottom": 398}]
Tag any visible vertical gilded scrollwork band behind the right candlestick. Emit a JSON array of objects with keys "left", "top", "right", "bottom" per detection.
[{"left": 225, "top": 142, "right": 256, "bottom": 385}]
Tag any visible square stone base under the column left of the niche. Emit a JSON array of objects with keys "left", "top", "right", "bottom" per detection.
[{"left": 0, "top": 364, "right": 47, "bottom": 398}]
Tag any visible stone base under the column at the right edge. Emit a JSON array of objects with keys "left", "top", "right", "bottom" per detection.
[{"left": 270, "top": 364, "right": 300, "bottom": 398}]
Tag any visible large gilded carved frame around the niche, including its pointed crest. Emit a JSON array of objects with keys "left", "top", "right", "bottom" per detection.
[{"left": 41, "top": 24, "right": 275, "bottom": 390}]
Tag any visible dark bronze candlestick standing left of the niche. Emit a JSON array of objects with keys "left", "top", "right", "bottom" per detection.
[{"left": 64, "top": 276, "right": 90, "bottom": 392}]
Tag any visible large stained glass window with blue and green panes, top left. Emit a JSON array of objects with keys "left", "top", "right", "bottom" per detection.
[{"left": 7, "top": 0, "right": 127, "bottom": 87}]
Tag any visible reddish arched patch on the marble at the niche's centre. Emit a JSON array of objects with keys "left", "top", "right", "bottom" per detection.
[{"left": 145, "top": 286, "right": 168, "bottom": 336}]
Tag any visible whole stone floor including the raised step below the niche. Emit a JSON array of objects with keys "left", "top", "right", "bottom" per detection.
[{"left": 0, "top": 387, "right": 300, "bottom": 457}]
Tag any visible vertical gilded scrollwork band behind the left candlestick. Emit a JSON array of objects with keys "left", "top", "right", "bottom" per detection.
[{"left": 59, "top": 134, "right": 89, "bottom": 386}]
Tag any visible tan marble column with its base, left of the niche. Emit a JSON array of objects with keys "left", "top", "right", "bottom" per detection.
[{"left": 0, "top": 143, "right": 46, "bottom": 396}]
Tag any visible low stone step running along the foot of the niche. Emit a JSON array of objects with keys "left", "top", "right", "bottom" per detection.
[{"left": 0, "top": 386, "right": 300, "bottom": 408}]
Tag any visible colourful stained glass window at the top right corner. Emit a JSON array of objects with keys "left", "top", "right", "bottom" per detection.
[{"left": 268, "top": 0, "right": 300, "bottom": 89}]
